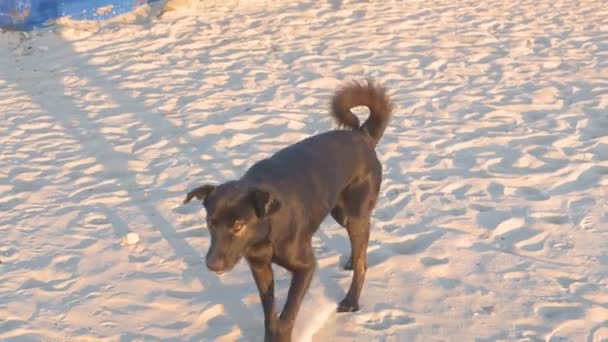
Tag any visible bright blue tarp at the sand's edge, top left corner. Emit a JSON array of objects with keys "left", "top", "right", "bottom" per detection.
[{"left": 0, "top": 0, "right": 159, "bottom": 30}]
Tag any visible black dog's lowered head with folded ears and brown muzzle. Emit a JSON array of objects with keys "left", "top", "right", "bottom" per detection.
[{"left": 184, "top": 182, "right": 281, "bottom": 274}]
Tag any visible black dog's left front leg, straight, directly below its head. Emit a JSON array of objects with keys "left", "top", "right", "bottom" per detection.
[{"left": 249, "top": 262, "right": 277, "bottom": 342}]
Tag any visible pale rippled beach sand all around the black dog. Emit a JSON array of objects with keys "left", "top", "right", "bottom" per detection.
[{"left": 0, "top": 0, "right": 608, "bottom": 342}]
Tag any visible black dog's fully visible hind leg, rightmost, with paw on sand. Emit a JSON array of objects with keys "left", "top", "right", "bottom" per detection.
[{"left": 338, "top": 217, "right": 370, "bottom": 312}]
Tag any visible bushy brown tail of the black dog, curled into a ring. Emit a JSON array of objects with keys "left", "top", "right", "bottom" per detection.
[{"left": 331, "top": 80, "right": 393, "bottom": 145}]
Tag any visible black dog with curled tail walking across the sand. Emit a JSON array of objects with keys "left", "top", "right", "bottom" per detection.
[{"left": 184, "top": 81, "right": 392, "bottom": 341}]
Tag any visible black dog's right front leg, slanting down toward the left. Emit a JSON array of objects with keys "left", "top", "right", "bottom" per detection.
[{"left": 276, "top": 258, "right": 315, "bottom": 342}]
